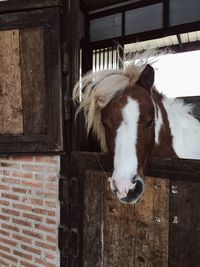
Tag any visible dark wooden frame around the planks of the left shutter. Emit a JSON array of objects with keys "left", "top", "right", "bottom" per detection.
[{"left": 0, "top": 7, "right": 64, "bottom": 154}]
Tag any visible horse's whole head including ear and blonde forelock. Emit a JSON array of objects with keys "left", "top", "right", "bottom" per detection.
[{"left": 73, "top": 58, "right": 159, "bottom": 203}]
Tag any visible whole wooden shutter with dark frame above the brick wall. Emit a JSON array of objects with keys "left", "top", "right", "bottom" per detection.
[{"left": 0, "top": 7, "right": 63, "bottom": 154}]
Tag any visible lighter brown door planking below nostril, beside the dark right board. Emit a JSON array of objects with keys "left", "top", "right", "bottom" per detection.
[{"left": 134, "top": 177, "right": 169, "bottom": 267}]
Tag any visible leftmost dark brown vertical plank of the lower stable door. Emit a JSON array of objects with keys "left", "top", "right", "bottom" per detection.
[{"left": 83, "top": 171, "right": 104, "bottom": 267}]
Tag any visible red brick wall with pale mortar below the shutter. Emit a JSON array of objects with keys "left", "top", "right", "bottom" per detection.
[{"left": 0, "top": 156, "right": 60, "bottom": 267}]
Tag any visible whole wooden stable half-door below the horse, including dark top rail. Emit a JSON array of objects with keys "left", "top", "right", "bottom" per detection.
[{"left": 71, "top": 152, "right": 200, "bottom": 267}]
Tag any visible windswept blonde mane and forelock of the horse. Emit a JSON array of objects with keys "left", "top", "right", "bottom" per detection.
[{"left": 73, "top": 50, "right": 163, "bottom": 151}]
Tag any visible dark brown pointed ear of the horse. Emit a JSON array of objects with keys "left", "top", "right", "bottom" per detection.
[{"left": 137, "top": 64, "right": 154, "bottom": 91}]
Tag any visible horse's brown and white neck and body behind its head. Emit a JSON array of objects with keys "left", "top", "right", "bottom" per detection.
[{"left": 152, "top": 91, "right": 200, "bottom": 159}]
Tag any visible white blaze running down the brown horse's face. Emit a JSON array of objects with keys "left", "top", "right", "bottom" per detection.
[{"left": 111, "top": 97, "right": 140, "bottom": 197}]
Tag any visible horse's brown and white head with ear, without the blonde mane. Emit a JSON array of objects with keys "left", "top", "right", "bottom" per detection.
[{"left": 101, "top": 65, "right": 155, "bottom": 203}]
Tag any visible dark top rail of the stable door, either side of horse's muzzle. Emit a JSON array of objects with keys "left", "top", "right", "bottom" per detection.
[{"left": 72, "top": 151, "right": 200, "bottom": 182}]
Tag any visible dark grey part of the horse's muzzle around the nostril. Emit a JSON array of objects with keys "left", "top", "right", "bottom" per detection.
[{"left": 119, "top": 176, "right": 144, "bottom": 204}]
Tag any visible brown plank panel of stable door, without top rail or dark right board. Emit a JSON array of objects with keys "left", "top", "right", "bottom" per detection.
[{"left": 83, "top": 171, "right": 169, "bottom": 267}]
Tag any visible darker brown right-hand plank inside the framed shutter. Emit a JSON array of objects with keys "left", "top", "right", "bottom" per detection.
[{"left": 20, "top": 28, "right": 46, "bottom": 134}]
